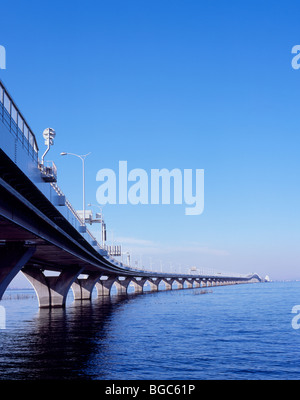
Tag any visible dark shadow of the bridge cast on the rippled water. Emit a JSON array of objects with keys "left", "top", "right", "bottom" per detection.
[{"left": 1, "top": 294, "right": 144, "bottom": 380}]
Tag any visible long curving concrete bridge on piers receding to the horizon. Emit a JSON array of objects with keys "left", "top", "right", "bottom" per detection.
[{"left": 0, "top": 81, "right": 261, "bottom": 307}]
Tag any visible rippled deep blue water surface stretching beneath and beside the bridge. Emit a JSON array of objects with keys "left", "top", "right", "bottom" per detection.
[{"left": 0, "top": 282, "right": 300, "bottom": 380}]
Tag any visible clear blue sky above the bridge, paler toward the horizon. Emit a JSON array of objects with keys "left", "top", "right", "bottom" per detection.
[{"left": 0, "top": 0, "right": 300, "bottom": 279}]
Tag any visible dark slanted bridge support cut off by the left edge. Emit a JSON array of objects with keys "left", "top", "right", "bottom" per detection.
[{"left": 0, "top": 242, "right": 35, "bottom": 300}]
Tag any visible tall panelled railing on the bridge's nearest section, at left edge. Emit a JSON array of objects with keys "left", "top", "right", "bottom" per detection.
[{"left": 0, "top": 81, "right": 39, "bottom": 162}]
